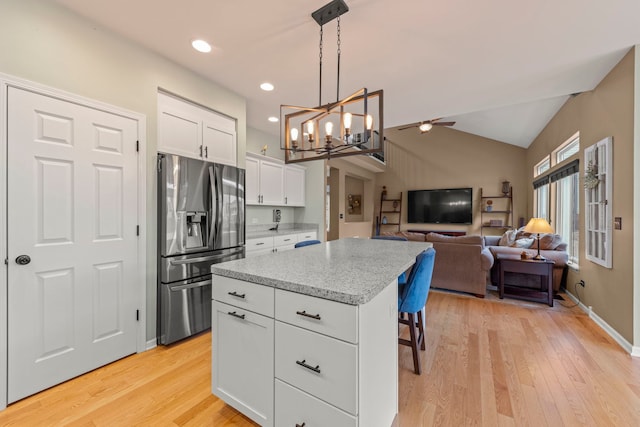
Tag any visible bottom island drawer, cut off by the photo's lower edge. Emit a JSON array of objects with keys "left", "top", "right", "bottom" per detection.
[{"left": 274, "top": 380, "right": 358, "bottom": 427}]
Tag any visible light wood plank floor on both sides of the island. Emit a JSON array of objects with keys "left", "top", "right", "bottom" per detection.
[{"left": 0, "top": 291, "right": 640, "bottom": 427}]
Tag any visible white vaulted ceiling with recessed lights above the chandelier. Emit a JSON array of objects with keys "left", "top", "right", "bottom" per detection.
[{"left": 56, "top": 0, "right": 640, "bottom": 147}]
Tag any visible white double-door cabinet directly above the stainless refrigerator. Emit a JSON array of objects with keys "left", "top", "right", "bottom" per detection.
[{"left": 158, "top": 93, "right": 238, "bottom": 166}]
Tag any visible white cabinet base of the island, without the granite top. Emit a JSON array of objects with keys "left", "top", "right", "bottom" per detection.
[{"left": 212, "top": 275, "right": 398, "bottom": 427}]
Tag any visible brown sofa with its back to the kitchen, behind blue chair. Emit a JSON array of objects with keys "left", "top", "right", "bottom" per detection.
[{"left": 383, "top": 231, "right": 493, "bottom": 298}]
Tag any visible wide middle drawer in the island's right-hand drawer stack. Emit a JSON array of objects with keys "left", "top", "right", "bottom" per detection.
[{"left": 275, "top": 321, "right": 358, "bottom": 415}]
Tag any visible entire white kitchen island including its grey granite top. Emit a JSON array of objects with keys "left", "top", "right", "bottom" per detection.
[{"left": 211, "top": 239, "right": 431, "bottom": 427}]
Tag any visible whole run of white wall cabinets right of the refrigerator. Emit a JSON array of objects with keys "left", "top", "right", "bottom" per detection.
[{"left": 246, "top": 153, "right": 307, "bottom": 207}]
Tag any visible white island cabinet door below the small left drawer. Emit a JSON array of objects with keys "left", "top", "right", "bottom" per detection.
[{"left": 211, "top": 301, "right": 274, "bottom": 426}]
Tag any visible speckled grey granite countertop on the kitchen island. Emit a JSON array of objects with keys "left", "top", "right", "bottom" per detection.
[{"left": 211, "top": 238, "right": 431, "bottom": 305}]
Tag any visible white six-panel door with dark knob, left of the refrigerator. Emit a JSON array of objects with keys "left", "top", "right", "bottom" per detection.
[{"left": 7, "top": 88, "right": 139, "bottom": 402}]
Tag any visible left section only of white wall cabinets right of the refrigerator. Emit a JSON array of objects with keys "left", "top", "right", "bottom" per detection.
[{"left": 245, "top": 154, "right": 284, "bottom": 206}]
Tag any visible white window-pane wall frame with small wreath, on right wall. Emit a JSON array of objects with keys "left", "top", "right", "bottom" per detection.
[{"left": 584, "top": 137, "right": 613, "bottom": 268}]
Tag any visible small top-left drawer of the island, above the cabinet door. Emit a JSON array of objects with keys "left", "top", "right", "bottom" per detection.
[{"left": 211, "top": 274, "right": 274, "bottom": 317}]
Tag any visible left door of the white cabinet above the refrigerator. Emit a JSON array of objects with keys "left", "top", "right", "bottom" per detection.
[{"left": 158, "top": 100, "right": 202, "bottom": 158}]
